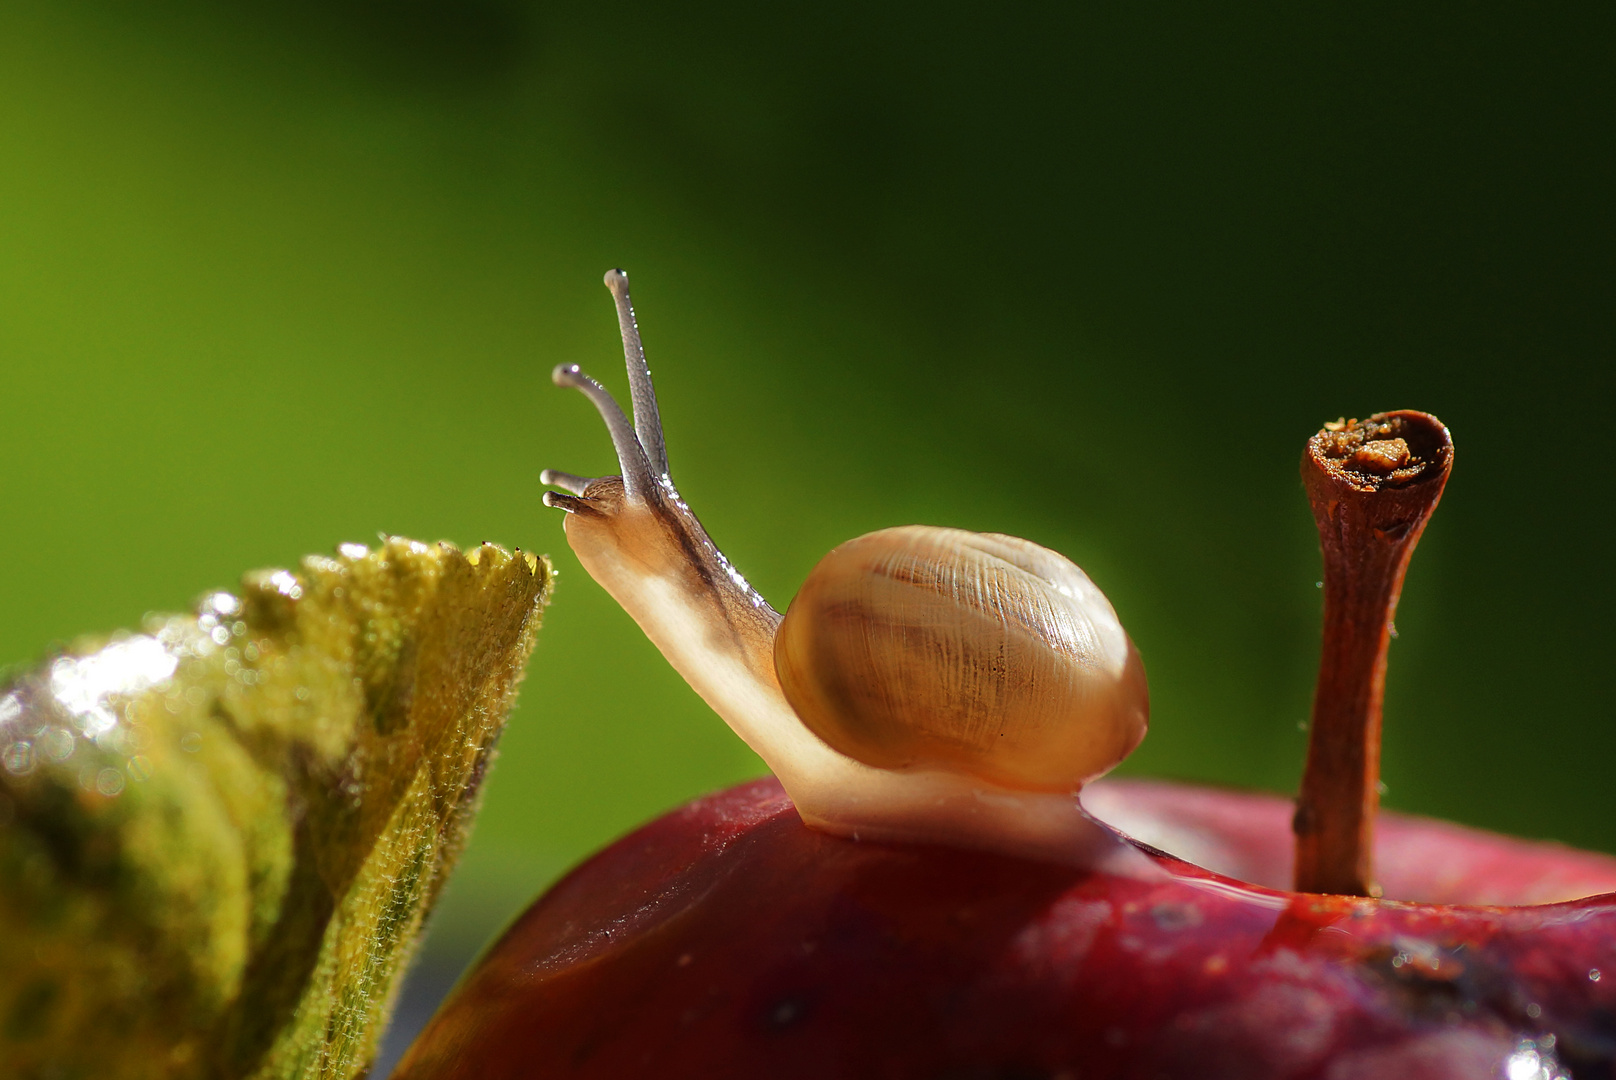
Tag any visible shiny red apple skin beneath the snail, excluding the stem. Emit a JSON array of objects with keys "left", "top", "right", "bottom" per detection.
[{"left": 394, "top": 779, "right": 1616, "bottom": 1080}]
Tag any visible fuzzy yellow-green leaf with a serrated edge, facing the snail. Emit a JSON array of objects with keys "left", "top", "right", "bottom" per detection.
[{"left": 0, "top": 538, "right": 551, "bottom": 1080}]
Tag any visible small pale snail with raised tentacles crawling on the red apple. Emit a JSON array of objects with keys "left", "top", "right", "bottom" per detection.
[{"left": 541, "top": 270, "right": 1149, "bottom": 863}]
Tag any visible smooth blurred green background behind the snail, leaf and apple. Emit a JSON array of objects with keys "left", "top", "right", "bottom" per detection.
[{"left": 0, "top": 0, "right": 1616, "bottom": 1060}]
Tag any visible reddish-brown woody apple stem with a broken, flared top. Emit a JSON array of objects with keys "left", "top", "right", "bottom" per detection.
[{"left": 1293, "top": 411, "right": 1453, "bottom": 896}]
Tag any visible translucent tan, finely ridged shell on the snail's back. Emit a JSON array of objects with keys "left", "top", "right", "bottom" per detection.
[{"left": 774, "top": 525, "right": 1149, "bottom": 791}]
